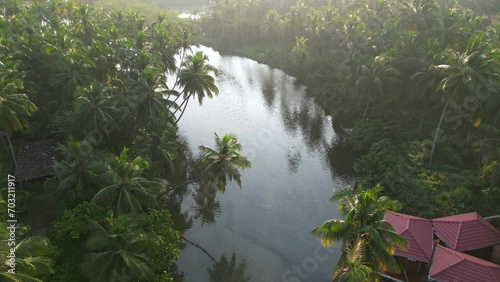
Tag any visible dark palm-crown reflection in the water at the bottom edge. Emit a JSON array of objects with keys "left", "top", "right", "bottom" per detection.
[{"left": 208, "top": 253, "right": 251, "bottom": 282}]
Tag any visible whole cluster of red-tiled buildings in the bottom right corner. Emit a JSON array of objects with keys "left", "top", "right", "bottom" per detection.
[{"left": 384, "top": 211, "right": 500, "bottom": 282}]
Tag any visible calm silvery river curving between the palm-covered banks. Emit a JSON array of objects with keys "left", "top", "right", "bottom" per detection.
[{"left": 177, "top": 47, "right": 352, "bottom": 282}]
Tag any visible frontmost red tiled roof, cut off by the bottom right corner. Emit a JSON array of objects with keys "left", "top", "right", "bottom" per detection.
[{"left": 429, "top": 245, "right": 500, "bottom": 282}]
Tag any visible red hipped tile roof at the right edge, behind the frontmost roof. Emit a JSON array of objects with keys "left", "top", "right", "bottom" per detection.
[{"left": 432, "top": 212, "right": 500, "bottom": 251}]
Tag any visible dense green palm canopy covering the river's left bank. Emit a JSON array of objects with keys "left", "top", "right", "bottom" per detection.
[{"left": 0, "top": 0, "right": 217, "bottom": 282}]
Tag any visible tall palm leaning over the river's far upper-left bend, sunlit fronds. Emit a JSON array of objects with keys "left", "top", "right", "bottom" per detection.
[{"left": 174, "top": 51, "right": 219, "bottom": 123}]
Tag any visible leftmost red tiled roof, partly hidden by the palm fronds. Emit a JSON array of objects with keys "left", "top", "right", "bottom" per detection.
[{"left": 384, "top": 211, "right": 433, "bottom": 262}]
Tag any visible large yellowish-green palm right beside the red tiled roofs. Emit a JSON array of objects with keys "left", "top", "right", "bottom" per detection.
[{"left": 312, "top": 185, "right": 408, "bottom": 281}]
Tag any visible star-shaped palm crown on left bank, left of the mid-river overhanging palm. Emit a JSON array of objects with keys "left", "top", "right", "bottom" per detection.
[{"left": 92, "top": 148, "right": 165, "bottom": 214}]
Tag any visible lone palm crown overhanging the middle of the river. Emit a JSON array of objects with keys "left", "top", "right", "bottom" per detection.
[{"left": 199, "top": 133, "right": 251, "bottom": 192}]
